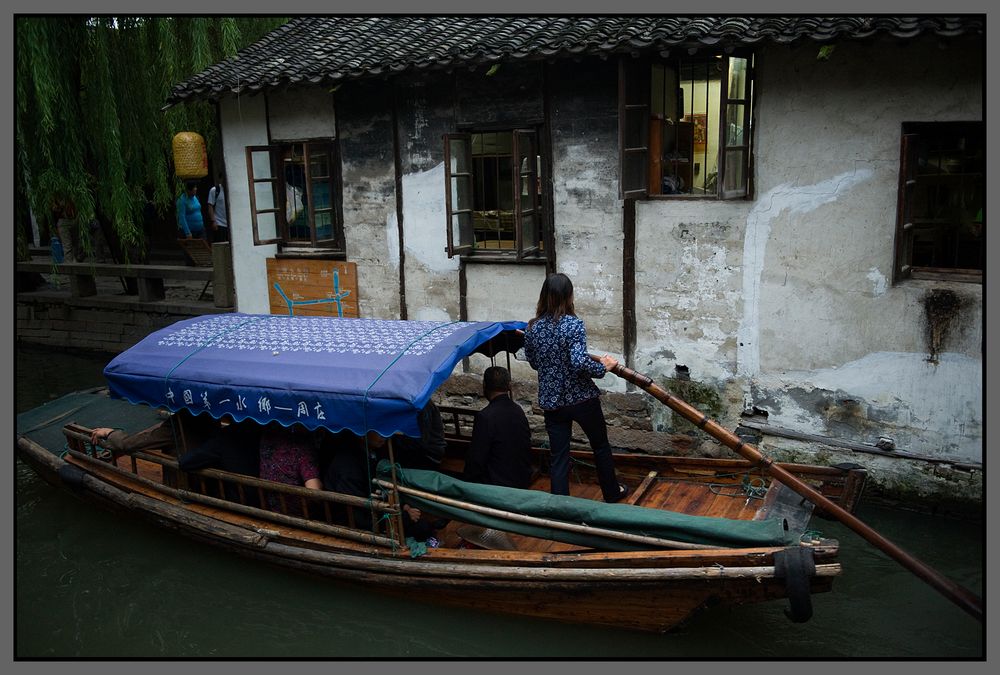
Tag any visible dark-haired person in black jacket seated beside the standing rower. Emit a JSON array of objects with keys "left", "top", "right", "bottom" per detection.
[{"left": 462, "top": 366, "right": 532, "bottom": 488}]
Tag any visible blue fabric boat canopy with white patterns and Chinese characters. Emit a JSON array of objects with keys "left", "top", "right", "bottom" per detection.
[{"left": 104, "top": 314, "right": 525, "bottom": 436}]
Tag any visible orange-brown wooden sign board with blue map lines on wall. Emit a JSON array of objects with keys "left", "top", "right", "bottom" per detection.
[{"left": 267, "top": 258, "right": 359, "bottom": 318}]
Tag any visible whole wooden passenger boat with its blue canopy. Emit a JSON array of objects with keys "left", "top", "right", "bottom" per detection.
[{"left": 17, "top": 314, "right": 865, "bottom": 631}]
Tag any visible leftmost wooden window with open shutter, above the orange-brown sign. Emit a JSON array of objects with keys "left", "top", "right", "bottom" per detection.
[{"left": 245, "top": 139, "right": 345, "bottom": 253}]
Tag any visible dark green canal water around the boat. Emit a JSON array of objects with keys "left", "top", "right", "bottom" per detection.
[{"left": 14, "top": 346, "right": 985, "bottom": 660}]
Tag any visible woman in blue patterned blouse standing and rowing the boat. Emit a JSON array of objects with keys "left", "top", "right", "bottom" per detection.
[{"left": 524, "top": 274, "right": 628, "bottom": 502}]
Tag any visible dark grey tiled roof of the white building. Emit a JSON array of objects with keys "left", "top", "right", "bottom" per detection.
[{"left": 168, "top": 15, "right": 985, "bottom": 103}]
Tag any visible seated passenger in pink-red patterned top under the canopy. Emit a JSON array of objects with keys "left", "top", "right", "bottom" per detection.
[{"left": 260, "top": 422, "right": 323, "bottom": 516}]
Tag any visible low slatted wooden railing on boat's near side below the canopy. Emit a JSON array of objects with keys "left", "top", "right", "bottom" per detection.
[{"left": 63, "top": 424, "right": 400, "bottom": 548}]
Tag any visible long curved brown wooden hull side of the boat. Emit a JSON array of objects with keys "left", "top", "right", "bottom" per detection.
[{"left": 17, "top": 437, "right": 840, "bottom": 631}]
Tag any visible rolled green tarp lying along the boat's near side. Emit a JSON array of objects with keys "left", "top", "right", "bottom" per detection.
[{"left": 378, "top": 460, "right": 796, "bottom": 551}]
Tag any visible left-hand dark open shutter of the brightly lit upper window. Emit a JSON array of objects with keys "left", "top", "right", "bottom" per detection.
[{"left": 618, "top": 56, "right": 650, "bottom": 199}]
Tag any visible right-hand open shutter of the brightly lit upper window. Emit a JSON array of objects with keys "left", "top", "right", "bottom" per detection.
[{"left": 719, "top": 57, "right": 752, "bottom": 199}]
